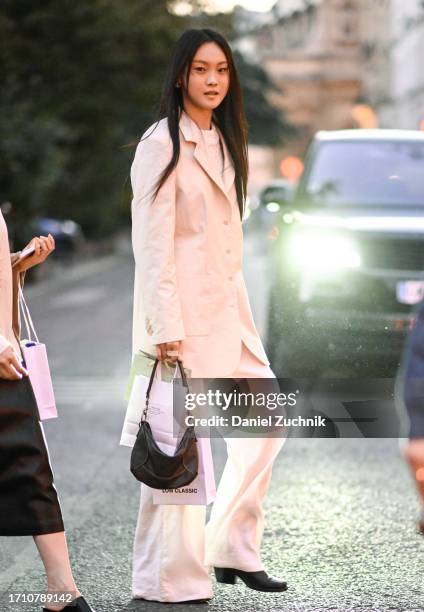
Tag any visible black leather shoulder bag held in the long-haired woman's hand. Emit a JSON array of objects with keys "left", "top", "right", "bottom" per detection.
[{"left": 130, "top": 359, "right": 199, "bottom": 490}]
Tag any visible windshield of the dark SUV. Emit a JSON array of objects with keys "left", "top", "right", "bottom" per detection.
[{"left": 304, "top": 141, "right": 424, "bottom": 206}]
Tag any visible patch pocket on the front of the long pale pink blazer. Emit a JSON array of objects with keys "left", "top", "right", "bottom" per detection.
[{"left": 178, "top": 274, "right": 212, "bottom": 336}]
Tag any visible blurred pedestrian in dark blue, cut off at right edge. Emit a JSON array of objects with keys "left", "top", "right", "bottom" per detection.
[{"left": 402, "top": 300, "right": 424, "bottom": 535}]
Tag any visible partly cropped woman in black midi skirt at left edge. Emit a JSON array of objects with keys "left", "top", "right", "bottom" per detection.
[{"left": 0, "top": 211, "right": 91, "bottom": 612}]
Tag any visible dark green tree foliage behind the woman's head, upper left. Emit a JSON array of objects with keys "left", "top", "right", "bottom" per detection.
[{"left": 0, "top": 0, "right": 292, "bottom": 236}]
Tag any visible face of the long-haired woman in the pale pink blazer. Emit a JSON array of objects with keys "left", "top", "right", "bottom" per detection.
[{"left": 183, "top": 42, "right": 230, "bottom": 110}]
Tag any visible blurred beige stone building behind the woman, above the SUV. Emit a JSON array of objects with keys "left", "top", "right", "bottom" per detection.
[{"left": 241, "top": 0, "right": 361, "bottom": 153}]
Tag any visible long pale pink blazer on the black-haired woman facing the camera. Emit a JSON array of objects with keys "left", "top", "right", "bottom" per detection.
[{"left": 131, "top": 112, "right": 269, "bottom": 377}]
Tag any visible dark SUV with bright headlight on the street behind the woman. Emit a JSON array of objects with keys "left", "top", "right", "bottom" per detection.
[{"left": 267, "top": 130, "right": 424, "bottom": 376}]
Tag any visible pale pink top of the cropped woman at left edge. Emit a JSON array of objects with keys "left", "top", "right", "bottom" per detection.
[{"left": 0, "top": 210, "right": 20, "bottom": 355}]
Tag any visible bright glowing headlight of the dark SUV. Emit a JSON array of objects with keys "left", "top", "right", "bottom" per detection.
[{"left": 290, "top": 232, "right": 361, "bottom": 273}]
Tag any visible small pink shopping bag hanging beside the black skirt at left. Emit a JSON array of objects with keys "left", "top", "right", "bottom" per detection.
[{"left": 20, "top": 290, "right": 57, "bottom": 421}]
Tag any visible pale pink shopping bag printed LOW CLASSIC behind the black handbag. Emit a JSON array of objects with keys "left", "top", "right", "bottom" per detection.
[{"left": 152, "top": 438, "right": 216, "bottom": 506}]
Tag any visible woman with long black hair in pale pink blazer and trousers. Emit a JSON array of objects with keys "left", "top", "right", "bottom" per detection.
[{"left": 131, "top": 29, "right": 287, "bottom": 602}]
